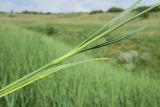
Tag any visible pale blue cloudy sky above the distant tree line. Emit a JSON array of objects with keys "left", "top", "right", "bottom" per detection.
[{"left": 0, "top": 0, "right": 160, "bottom": 12}]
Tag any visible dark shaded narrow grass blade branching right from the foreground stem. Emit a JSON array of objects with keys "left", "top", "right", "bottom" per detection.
[{"left": 80, "top": 26, "right": 149, "bottom": 52}]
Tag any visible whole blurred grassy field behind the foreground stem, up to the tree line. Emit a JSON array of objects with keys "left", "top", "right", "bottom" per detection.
[{"left": 0, "top": 13, "right": 160, "bottom": 107}]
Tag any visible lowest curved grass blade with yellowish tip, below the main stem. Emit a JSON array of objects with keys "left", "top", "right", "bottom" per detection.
[{"left": 0, "top": 58, "right": 109, "bottom": 97}]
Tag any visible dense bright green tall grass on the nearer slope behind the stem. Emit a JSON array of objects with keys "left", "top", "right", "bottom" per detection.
[{"left": 0, "top": 26, "right": 160, "bottom": 107}]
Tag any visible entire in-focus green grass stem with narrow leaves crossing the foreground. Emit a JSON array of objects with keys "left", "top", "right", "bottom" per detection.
[{"left": 0, "top": 0, "right": 160, "bottom": 97}]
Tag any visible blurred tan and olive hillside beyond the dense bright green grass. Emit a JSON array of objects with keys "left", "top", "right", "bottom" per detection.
[{"left": 0, "top": 12, "right": 160, "bottom": 73}]
